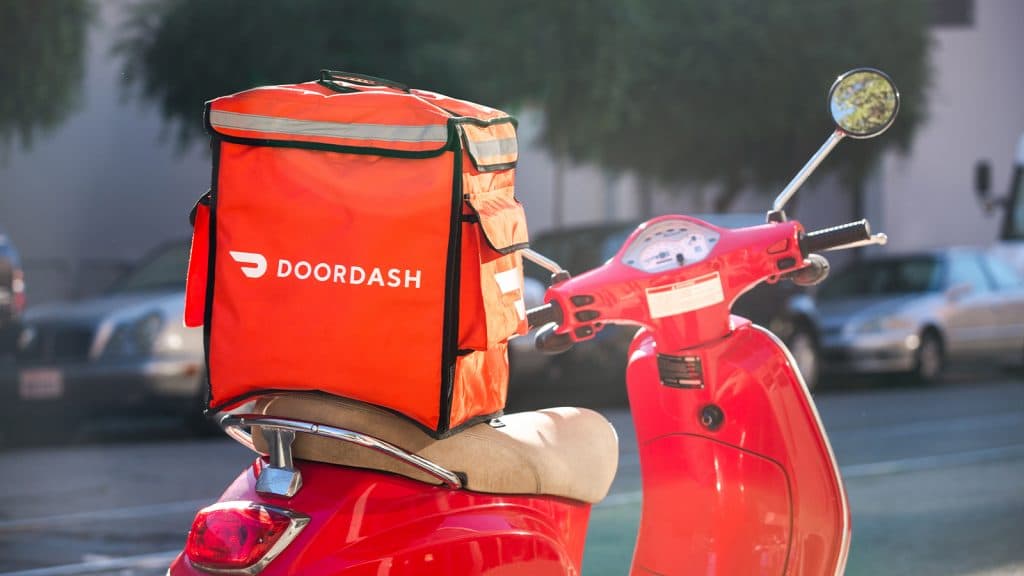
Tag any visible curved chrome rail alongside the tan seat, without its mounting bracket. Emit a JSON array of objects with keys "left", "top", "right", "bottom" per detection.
[{"left": 220, "top": 414, "right": 462, "bottom": 490}]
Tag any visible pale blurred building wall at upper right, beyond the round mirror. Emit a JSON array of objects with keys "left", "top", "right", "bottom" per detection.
[{"left": 873, "top": 0, "right": 1024, "bottom": 250}]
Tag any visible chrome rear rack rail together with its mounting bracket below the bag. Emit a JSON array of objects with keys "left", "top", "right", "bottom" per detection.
[{"left": 217, "top": 413, "right": 462, "bottom": 498}]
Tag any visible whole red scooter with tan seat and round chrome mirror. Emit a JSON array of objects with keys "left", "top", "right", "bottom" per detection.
[{"left": 169, "top": 69, "right": 899, "bottom": 576}]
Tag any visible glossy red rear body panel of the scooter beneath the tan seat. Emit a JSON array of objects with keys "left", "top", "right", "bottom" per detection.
[{"left": 169, "top": 459, "right": 590, "bottom": 576}]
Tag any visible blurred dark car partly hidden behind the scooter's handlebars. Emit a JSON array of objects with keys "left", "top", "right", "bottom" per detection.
[{"left": 509, "top": 214, "right": 818, "bottom": 408}]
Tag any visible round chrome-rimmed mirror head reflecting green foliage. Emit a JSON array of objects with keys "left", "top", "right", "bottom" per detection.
[{"left": 828, "top": 68, "right": 899, "bottom": 138}]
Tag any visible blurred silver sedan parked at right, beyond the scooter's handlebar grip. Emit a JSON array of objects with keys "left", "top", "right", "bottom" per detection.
[{"left": 817, "top": 248, "right": 1024, "bottom": 382}]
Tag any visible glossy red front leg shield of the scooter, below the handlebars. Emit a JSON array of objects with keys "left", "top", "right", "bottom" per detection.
[{"left": 627, "top": 323, "right": 850, "bottom": 576}]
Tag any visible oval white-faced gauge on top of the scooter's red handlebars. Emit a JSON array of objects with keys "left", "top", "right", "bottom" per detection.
[{"left": 623, "top": 218, "right": 719, "bottom": 273}]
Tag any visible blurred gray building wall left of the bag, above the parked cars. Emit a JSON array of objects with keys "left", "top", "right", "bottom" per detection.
[{"left": 0, "top": 2, "right": 210, "bottom": 305}]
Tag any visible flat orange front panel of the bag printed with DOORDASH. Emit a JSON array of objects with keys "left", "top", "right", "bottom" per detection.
[{"left": 209, "top": 142, "right": 454, "bottom": 429}]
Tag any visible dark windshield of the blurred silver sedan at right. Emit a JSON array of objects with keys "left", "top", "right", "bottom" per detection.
[{"left": 818, "top": 256, "right": 940, "bottom": 300}]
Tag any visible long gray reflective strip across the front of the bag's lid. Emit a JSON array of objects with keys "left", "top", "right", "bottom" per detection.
[{"left": 210, "top": 110, "right": 447, "bottom": 143}]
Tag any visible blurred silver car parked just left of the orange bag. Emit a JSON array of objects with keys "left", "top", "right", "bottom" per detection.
[{"left": 6, "top": 242, "right": 205, "bottom": 434}]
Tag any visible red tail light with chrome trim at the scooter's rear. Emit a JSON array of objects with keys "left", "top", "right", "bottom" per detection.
[{"left": 185, "top": 502, "right": 309, "bottom": 574}]
